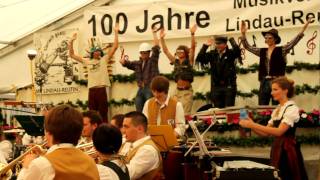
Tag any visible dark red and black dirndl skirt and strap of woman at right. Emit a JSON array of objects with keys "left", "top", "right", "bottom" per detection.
[{"left": 270, "top": 104, "right": 308, "bottom": 180}]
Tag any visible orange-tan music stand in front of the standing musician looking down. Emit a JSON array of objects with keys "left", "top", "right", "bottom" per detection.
[{"left": 148, "top": 125, "right": 178, "bottom": 152}]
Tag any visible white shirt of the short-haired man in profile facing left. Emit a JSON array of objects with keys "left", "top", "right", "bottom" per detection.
[{"left": 119, "top": 136, "right": 160, "bottom": 179}]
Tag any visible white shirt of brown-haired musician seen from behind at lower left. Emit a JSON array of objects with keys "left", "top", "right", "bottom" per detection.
[{"left": 18, "top": 143, "right": 74, "bottom": 180}]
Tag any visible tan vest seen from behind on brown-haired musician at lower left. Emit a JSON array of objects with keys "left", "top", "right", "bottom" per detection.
[{"left": 44, "top": 148, "right": 100, "bottom": 180}]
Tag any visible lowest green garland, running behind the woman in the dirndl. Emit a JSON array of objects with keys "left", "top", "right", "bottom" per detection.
[{"left": 212, "top": 134, "right": 320, "bottom": 147}]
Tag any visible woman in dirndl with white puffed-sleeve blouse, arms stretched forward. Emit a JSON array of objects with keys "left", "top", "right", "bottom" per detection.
[{"left": 239, "top": 77, "right": 308, "bottom": 180}]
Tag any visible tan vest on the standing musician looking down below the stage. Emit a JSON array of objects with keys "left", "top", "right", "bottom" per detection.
[{"left": 148, "top": 97, "right": 177, "bottom": 125}]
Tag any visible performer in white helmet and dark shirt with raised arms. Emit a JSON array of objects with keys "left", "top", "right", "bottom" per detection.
[{"left": 120, "top": 29, "right": 160, "bottom": 112}]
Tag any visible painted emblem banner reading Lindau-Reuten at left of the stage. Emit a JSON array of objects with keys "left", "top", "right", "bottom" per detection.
[{"left": 34, "top": 29, "right": 80, "bottom": 94}]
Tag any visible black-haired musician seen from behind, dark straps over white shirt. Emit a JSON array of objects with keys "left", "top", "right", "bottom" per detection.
[{"left": 92, "top": 124, "right": 130, "bottom": 180}]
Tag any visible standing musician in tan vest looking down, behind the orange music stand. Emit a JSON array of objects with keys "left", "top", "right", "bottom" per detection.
[{"left": 143, "top": 76, "right": 185, "bottom": 136}]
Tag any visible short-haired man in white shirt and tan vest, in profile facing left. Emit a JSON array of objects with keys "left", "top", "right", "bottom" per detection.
[{"left": 119, "top": 111, "right": 161, "bottom": 180}]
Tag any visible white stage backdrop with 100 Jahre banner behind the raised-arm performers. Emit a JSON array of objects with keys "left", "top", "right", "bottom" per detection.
[{"left": 18, "top": 0, "right": 320, "bottom": 114}]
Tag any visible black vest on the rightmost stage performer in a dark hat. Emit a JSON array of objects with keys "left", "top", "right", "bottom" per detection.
[{"left": 259, "top": 47, "right": 287, "bottom": 80}]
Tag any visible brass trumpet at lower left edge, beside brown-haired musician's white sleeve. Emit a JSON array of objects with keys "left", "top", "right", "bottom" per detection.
[{"left": 0, "top": 143, "right": 46, "bottom": 179}]
